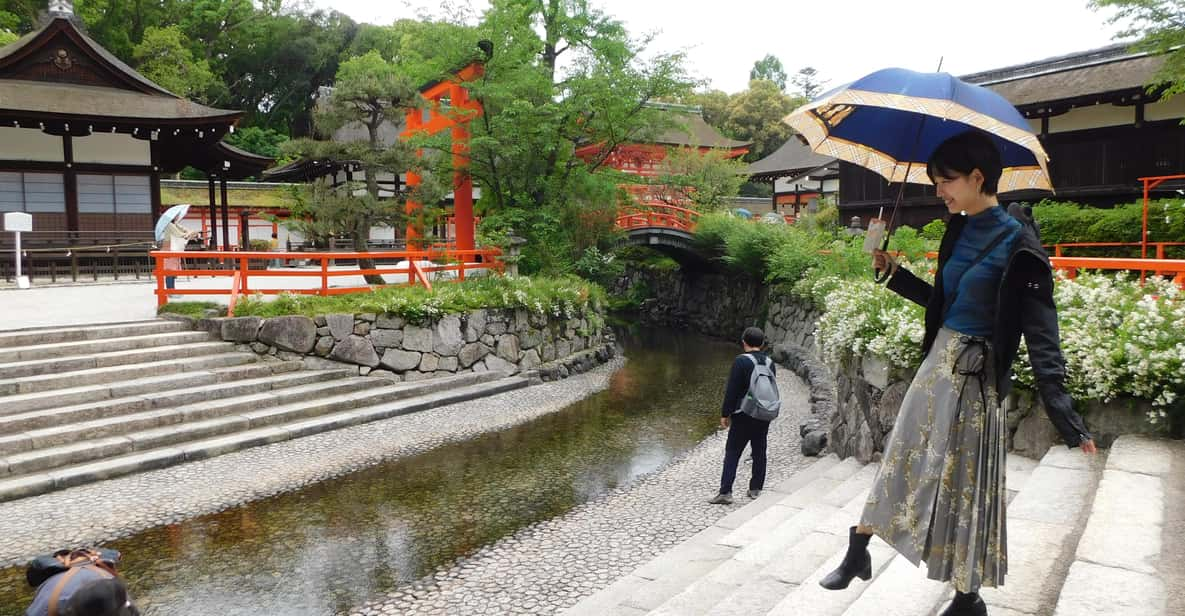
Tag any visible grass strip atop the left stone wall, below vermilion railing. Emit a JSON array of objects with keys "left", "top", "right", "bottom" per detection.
[{"left": 235, "top": 276, "right": 606, "bottom": 322}]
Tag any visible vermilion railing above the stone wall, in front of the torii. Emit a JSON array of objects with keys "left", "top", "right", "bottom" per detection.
[{"left": 149, "top": 248, "right": 505, "bottom": 316}]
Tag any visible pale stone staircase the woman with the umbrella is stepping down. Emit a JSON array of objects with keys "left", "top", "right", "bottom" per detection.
[{"left": 564, "top": 436, "right": 1185, "bottom": 616}]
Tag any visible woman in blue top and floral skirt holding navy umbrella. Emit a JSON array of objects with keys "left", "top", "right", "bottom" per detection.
[{"left": 787, "top": 70, "right": 1095, "bottom": 616}]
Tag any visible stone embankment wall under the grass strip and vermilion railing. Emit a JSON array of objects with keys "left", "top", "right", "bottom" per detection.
[{"left": 189, "top": 309, "right": 616, "bottom": 381}]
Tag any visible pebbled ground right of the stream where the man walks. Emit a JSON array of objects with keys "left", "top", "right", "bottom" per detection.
[{"left": 350, "top": 370, "right": 814, "bottom": 616}]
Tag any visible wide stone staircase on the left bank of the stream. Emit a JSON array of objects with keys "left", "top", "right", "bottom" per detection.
[{"left": 0, "top": 321, "right": 529, "bottom": 501}]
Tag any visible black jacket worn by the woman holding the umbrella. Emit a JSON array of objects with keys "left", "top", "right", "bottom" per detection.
[{"left": 889, "top": 206, "right": 1091, "bottom": 448}]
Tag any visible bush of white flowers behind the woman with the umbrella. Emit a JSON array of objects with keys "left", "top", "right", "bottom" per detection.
[{"left": 810, "top": 274, "right": 1185, "bottom": 422}]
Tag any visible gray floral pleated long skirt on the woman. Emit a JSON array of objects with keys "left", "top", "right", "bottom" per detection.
[{"left": 860, "top": 328, "right": 1007, "bottom": 592}]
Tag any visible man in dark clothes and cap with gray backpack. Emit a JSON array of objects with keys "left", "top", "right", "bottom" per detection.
[{"left": 709, "top": 327, "right": 781, "bottom": 505}]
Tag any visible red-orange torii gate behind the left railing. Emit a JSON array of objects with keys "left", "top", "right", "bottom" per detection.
[{"left": 399, "top": 62, "right": 486, "bottom": 250}]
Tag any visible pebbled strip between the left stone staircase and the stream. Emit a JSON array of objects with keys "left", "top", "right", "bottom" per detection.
[{"left": 0, "top": 359, "right": 623, "bottom": 566}]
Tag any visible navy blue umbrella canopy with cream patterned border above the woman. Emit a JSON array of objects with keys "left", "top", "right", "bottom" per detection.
[{"left": 784, "top": 69, "right": 1053, "bottom": 192}]
